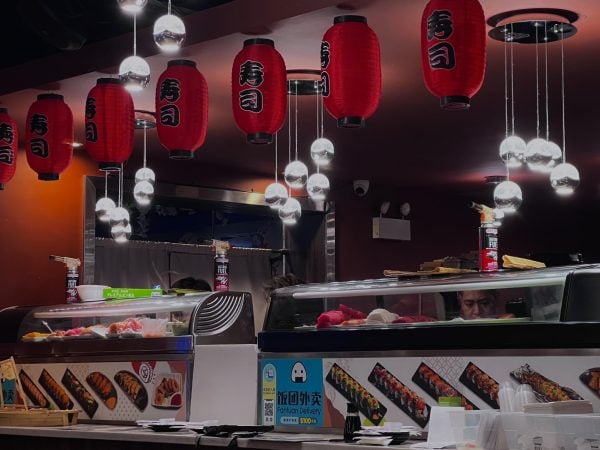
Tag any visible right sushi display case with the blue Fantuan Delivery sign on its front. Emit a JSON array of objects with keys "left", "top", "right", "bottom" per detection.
[{"left": 258, "top": 265, "right": 600, "bottom": 431}]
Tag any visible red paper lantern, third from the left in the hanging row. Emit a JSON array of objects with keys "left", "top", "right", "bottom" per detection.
[{"left": 85, "top": 78, "right": 135, "bottom": 171}]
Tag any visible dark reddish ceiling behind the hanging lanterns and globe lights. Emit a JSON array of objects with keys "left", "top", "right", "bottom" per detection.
[{"left": 0, "top": 0, "right": 600, "bottom": 196}]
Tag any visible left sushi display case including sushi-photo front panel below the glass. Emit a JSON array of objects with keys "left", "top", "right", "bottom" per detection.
[{"left": 0, "top": 292, "right": 256, "bottom": 423}]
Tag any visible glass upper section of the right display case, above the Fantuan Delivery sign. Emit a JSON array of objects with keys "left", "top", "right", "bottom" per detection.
[{"left": 264, "top": 265, "right": 600, "bottom": 331}]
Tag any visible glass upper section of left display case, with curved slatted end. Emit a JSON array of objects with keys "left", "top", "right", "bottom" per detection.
[{"left": 13, "top": 292, "right": 254, "bottom": 343}]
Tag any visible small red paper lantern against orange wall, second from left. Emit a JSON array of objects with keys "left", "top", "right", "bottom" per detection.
[{"left": 25, "top": 94, "right": 73, "bottom": 181}]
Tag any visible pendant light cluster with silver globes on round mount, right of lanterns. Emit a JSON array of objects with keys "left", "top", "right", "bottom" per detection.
[{"left": 488, "top": 8, "right": 580, "bottom": 202}]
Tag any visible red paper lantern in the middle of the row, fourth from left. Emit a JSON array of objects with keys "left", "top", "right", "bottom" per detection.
[{"left": 155, "top": 59, "right": 208, "bottom": 159}]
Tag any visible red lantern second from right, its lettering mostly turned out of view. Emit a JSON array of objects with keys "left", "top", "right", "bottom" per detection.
[{"left": 321, "top": 16, "right": 381, "bottom": 128}]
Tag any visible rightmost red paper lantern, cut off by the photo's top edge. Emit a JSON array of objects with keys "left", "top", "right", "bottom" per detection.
[{"left": 421, "top": 0, "right": 485, "bottom": 110}]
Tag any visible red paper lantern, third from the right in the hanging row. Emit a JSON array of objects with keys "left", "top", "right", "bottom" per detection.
[{"left": 231, "top": 38, "right": 287, "bottom": 144}]
